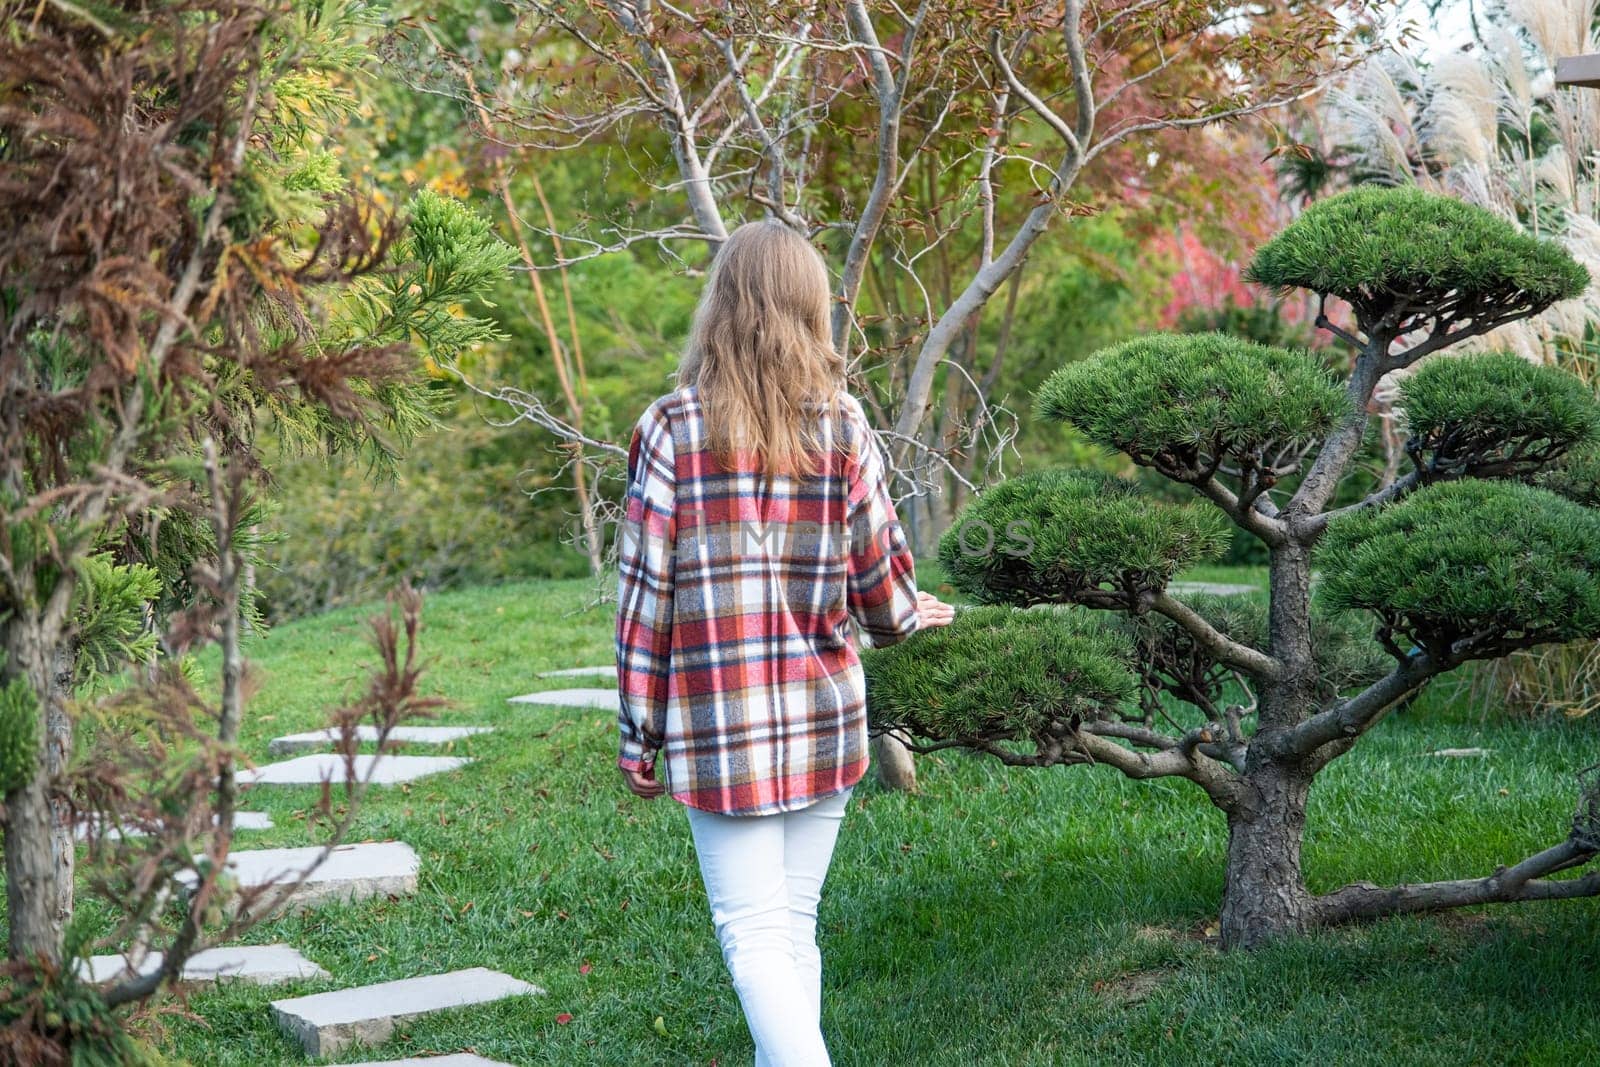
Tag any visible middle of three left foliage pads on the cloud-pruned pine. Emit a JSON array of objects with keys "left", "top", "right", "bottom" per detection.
[{"left": 939, "top": 470, "right": 1227, "bottom": 605}]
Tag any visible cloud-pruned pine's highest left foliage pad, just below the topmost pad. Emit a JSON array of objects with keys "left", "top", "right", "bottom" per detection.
[{"left": 1035, "top": 333, "right": 1347, "bottom": 475}]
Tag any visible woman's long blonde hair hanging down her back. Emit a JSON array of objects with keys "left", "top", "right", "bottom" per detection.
[{"left": 678, "top": 219, "right": 845, "bottom": 475}]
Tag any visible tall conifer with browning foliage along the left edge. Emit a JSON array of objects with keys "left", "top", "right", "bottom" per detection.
[{"left": 0, "top": 0, "right": 512, "bottom": 1062}]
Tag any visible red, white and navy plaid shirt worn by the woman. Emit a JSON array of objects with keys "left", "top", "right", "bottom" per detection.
[{"left": 616, "top": 386, "right": 917, "bottom": 814}]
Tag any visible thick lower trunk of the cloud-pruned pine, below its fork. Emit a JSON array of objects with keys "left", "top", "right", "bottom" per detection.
[{"left": 1221, "top": 766, "right": 1312, "bottom": 949}]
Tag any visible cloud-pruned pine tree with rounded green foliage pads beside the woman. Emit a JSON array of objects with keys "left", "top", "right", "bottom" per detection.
[{"left": 866, "top": 189, "right": 1600, "bottom": 947}]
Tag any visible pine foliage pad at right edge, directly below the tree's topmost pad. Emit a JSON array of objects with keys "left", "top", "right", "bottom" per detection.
[{"left": 1400, "top": 352, "right": 1600, "bottom": 474}]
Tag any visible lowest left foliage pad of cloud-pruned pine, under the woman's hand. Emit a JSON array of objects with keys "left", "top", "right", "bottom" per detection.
[{"left": 862, "top": 605, "right": 1138, "bottom": 751}]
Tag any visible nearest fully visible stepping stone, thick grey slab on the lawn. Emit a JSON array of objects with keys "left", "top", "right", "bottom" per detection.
[{"left": 272, "top": 966, "right": 544, "bottom": 1062}]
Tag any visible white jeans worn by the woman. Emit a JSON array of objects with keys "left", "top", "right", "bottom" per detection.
[{"left": 685, "top": 787, "right": 854, "bottom": 1067}]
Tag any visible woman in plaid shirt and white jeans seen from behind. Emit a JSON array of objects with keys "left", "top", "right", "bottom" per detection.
[{"left": 616, "top": 221, "right": 952, "bottom": 1067}]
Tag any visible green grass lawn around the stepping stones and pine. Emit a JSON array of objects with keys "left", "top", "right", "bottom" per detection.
[{"left": 100, "top": 568, "right": 1600, "bottom": 1067}]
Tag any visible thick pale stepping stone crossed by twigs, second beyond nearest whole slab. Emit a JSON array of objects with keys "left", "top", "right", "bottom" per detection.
[{"left": 178, "top": 841, "right": 422, "bottom": 909}]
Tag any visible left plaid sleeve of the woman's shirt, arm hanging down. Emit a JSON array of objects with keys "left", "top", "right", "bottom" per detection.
[{"left": 616, "top": 403, "right": 677, "bottom": 771}]
